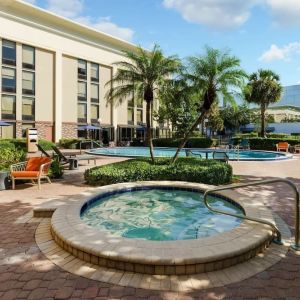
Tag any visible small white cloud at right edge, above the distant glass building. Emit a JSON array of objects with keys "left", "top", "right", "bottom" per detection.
[{"left": 259, "top": 42, "right": 300, "bottom": 62}]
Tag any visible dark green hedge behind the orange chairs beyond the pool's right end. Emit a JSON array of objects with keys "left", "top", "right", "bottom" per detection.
[{"left": 233, "top": 138, "right": 300, "bottom": 151}]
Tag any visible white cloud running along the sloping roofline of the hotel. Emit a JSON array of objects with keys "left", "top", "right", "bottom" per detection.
[{"left": 46, "top": 0, "right": 134, "bottom": 41}]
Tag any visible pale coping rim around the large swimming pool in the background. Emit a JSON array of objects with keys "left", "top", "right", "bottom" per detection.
[{"left": 85, "top": 146, "right": 293, "bottom": 162}]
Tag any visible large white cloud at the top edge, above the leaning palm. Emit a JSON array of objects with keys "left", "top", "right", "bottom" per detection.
[{"left": 163, "top": 0, "right": 260, "bottom": 28}]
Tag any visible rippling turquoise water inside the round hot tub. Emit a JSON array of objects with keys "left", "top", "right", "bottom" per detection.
[{"left": 81, "top": 188, "right": 243, "bottom": 241}]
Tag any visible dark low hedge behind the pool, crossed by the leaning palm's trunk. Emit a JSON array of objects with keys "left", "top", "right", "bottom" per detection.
[{"left": 153, "top": 137, "right": 213, "bottom": 148}]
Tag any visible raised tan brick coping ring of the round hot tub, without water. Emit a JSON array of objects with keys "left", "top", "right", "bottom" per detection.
[{"left": 51, "top": 181, "right": 275, "bottom": 275}]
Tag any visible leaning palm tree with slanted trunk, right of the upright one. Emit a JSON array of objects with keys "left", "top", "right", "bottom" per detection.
[{"left": 172, "top": 47, "right": 247, "bottom": 163}]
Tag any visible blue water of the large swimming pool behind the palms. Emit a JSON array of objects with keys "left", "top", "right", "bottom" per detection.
[{"left": 89, "top": 147, "right": 287, "bottom": 160}]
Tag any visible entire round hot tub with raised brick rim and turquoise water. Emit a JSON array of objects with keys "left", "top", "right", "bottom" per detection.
[{"left": 51, "top": 181, "right": 273, "bottom": 275}]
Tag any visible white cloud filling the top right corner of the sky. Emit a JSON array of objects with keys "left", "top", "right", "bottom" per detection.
[{"left": 265, "top": 0, "right": 300, "bottom": 25}]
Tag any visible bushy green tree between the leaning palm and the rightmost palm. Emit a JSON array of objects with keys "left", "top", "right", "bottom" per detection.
[{"left": 221, "top": 104, "right": 254, "bottom": 131}]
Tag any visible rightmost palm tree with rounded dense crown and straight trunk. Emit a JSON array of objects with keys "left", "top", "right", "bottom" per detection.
[{"left": 245, "top": 69, "right": 282, "bottom": 137}]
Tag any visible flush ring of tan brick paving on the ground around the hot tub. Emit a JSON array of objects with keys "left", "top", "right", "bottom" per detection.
[{"left": 35, "top": 213, "right": 291, "bottom": 292}]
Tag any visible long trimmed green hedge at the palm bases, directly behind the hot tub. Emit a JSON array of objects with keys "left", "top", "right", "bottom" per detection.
[{"left": 84, "top": 157, "right": 232, "bottom": 186}]
